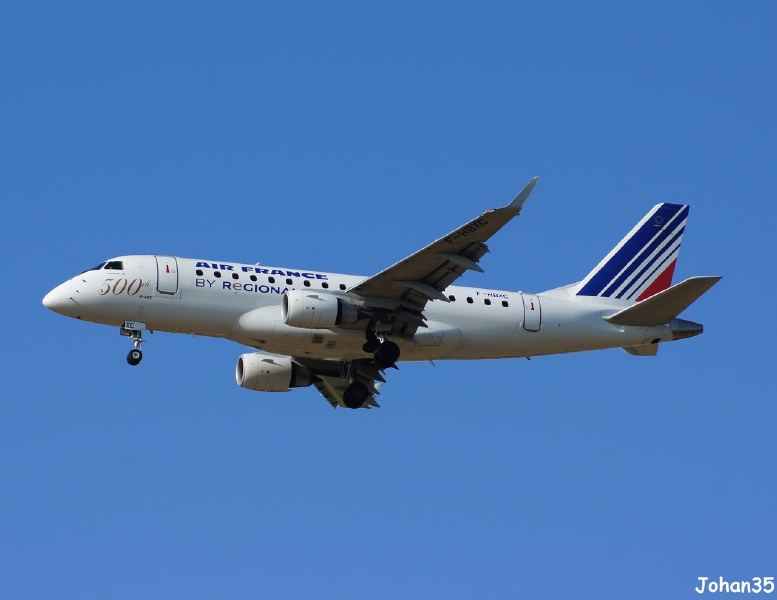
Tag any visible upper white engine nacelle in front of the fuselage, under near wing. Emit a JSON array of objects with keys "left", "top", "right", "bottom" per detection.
[{"left": 282, "top": 290, "right": 359, "bottom": 329}]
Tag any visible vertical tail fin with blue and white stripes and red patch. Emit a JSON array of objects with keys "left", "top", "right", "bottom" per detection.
[{"left": 577, "top": 203, "right": 689, "bottom": 302}]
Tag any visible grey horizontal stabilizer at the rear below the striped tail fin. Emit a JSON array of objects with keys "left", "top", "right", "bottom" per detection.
[{"left": 604, "top": 276, "right": 721, "bottom": 325}]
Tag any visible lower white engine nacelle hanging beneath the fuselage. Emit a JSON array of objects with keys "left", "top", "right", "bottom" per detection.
[{"left": 235, "top": 352, "right": 313, "bottom": 392}]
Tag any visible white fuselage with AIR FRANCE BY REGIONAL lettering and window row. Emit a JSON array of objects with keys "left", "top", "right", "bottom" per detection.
[{"left": 44, "top": 255, "right": 672, "bottom": 361}]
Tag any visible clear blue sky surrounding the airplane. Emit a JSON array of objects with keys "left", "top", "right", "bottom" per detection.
[{"left": 0, "top": 2, "right": 777, "bottom": 599}]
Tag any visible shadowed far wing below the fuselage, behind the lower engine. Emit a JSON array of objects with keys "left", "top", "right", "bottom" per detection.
[{"left": 294, "top": 357, "right": 386, "bottom": 408}]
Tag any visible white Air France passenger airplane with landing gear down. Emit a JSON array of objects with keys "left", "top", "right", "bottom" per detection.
[{"left": 43, "top": 177, "right": 721, "bottom": 409}]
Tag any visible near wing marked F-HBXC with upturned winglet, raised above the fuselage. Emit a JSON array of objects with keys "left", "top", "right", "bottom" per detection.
[{"left": 348, "top": 177, "right": 539, "bottom": 336}]
